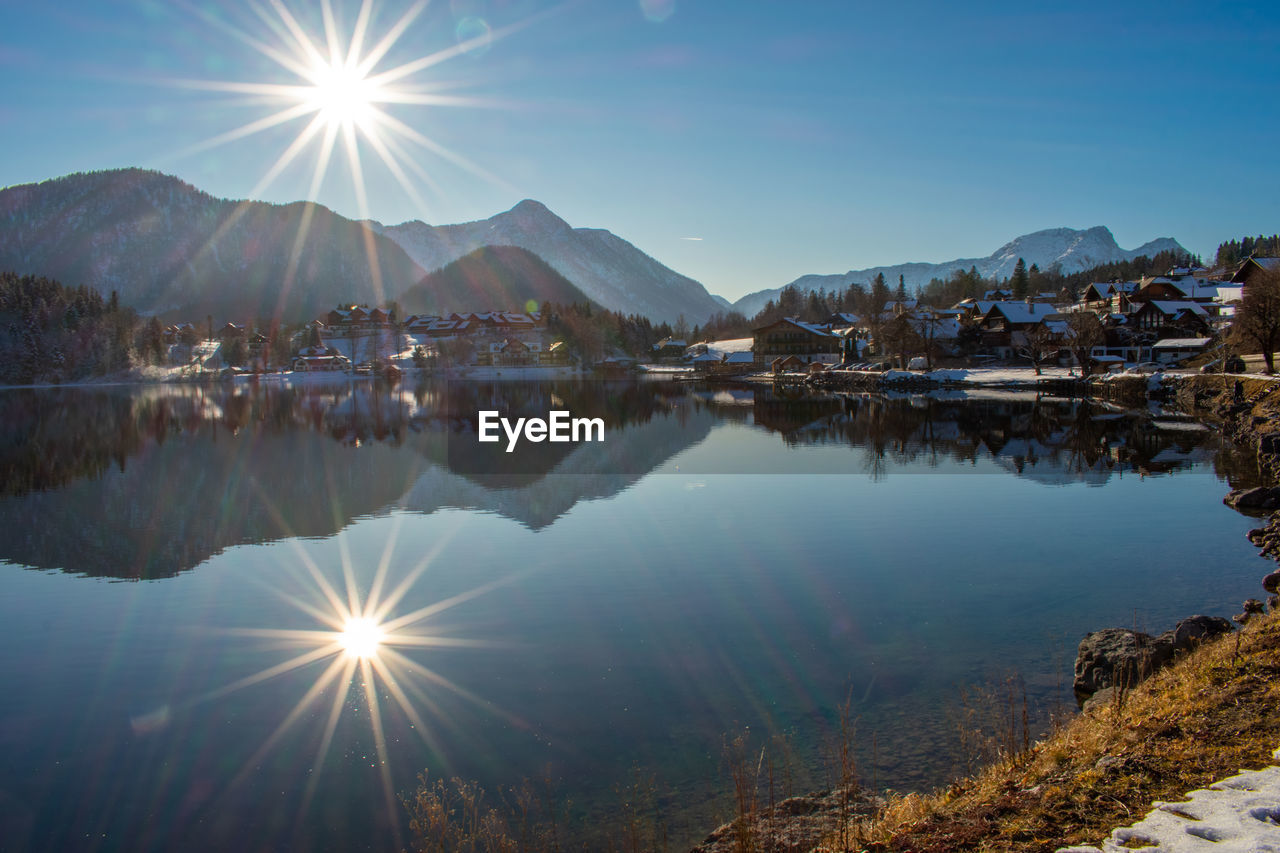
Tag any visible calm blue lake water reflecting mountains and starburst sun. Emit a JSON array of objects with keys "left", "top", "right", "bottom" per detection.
[{"left": 0, "top": 383, "right": 1267, "bottom": 850}]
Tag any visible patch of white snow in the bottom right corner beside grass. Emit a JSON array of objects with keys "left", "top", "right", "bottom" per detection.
[{"left": 1059, "top": 749, "right": 1280, "bottom": 853}]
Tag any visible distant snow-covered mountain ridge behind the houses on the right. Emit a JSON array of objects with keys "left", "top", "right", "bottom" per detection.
[{"left": 733, "top": 225, "right": 1188, "bottom": 316}]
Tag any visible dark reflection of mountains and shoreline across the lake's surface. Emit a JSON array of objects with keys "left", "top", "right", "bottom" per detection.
[{"left": 0, "top": 382, "right": 1252, "bottom": 579}]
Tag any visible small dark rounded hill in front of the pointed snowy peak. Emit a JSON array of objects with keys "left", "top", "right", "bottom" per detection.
[{"left": 399, "top": 246, "right": 590, "bottom": 315}]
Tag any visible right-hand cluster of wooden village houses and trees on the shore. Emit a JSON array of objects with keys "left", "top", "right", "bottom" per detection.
[{"left": 654, "top": 257, "right": 1280, "bottom": 377}]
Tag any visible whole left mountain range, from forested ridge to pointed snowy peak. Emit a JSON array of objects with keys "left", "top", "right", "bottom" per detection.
[{"left": 0, "top": 169, "right": 724, "bottom": 324}]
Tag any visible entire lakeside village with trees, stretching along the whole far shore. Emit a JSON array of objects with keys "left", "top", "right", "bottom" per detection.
[{"left": 149, "top": 256, "right": 1280, "bottom": 378}]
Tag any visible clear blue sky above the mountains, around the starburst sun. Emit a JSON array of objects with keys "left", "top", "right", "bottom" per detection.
[{"left": 0, "top": 0, "right": 1280, "bottom": 298}]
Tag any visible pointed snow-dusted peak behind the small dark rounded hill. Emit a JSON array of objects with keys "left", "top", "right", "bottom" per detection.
[{"left": 366, "top": 199, "right": 724, "bottom": 324}]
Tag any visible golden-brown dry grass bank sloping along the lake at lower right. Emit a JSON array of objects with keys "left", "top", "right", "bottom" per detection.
[{"left": 819, "top": 613, "right": 1280, "bottom": 853}]
